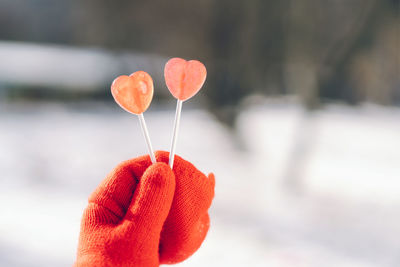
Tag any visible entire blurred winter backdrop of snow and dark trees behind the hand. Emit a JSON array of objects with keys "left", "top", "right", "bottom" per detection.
[{"left": 0, "top": 0, "right": 400, "bottom": 267}]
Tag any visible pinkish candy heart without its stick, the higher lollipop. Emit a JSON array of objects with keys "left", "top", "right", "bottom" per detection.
[{"left": 164, "top": 58, "right": 207, "bottom": 101}]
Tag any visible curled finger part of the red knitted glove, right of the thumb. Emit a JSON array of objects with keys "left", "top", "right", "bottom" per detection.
[{"left": 156, "top": 152, "right": 215, "bottom": 264}]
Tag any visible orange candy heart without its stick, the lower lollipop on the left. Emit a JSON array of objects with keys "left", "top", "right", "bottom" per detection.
[{"left": 111, "top": 71, "right": 154, "bottom": 114}]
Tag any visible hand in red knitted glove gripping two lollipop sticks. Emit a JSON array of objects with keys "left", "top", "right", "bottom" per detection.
[{"left": 75, "top": 152, "right": 215, "bottom": 267}]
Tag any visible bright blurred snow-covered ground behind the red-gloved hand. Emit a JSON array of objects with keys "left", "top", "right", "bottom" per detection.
[{"left": 0, "top": 101, "right": 400, "bottom": 267}]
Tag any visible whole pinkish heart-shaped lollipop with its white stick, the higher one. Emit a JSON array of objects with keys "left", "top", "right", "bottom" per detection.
[{"left": 164, "top": 57, "right": 207, "bottom": 169}]
